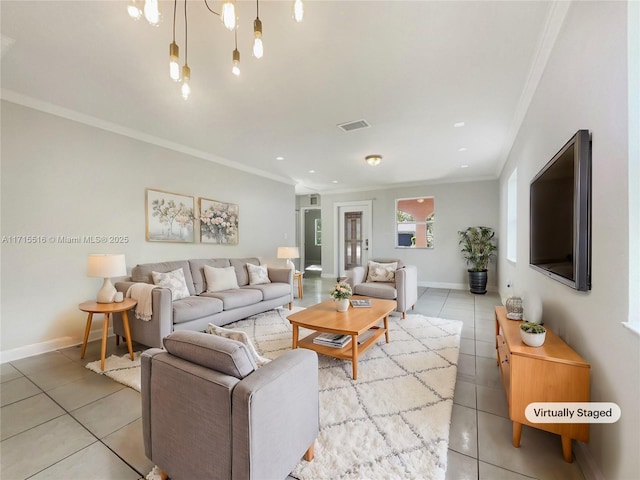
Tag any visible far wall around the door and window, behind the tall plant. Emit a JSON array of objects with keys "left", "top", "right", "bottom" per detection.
[{"left": 322, "top": 180, "right": 499, "bottom": 289}]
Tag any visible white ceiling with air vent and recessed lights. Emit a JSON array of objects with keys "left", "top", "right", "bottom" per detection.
[{"left": 0, "top": 0, "right": 556, "bottom": 194}]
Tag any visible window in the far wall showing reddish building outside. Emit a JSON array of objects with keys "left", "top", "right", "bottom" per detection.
[{"left": 396, "top": 197, "right": 435, "bottom": 248}]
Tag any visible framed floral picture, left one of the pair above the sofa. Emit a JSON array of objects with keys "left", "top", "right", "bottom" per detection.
[{"left": 145, "top": 188, "right": 195, "bottom": 243}]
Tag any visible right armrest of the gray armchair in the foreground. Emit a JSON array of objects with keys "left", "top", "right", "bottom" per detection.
[{"left": 232, "top": 349, "right": 319, "bottom": 480}]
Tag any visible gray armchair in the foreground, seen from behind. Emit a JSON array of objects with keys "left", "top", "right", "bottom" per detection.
[{"left": 141, "top": 331, "right": 319, "bottom": 480}]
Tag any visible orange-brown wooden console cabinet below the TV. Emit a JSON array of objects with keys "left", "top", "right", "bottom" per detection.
[{"left": 495, "top": 306, "right": 591, "bottom": 462}]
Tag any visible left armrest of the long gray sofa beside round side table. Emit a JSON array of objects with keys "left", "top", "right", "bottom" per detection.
[{"left": 113, "top": 281, "right": 173, "bottom": 348}]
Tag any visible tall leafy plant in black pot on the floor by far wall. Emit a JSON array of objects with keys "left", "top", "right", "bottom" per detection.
[{"left": 458, "top": 227, "right": 498, "bottom": 294}]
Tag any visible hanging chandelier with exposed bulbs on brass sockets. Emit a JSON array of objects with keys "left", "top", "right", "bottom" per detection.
[{"left": 127, "top": 0, "right": 304, "bottom": 100}]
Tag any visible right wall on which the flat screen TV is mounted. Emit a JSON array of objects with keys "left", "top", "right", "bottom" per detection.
[{"left": 499, "top": 2, "right": 640, "bottom": 479}]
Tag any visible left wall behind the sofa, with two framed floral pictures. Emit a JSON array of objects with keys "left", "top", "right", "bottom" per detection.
[{"left": 0, "top": 101, "right": 295, "bottom": 361}]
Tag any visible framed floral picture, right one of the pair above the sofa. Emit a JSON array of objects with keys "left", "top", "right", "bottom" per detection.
[{"left": 199, "top": 198, "right": 238, "bottom": 245}]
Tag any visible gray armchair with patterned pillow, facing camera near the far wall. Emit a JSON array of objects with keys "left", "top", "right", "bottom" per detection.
[{"left": 346, "top": 260, "right": 418, "bottom": 318}]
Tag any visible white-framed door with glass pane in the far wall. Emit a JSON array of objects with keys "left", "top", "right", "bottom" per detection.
[{"left": 337, "top": 202, "right": 371, "bottom": 277}]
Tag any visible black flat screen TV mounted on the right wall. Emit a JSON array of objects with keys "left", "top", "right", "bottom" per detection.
[{"left": 529, "top": 130, "right": 591, "bottom": 291}]
